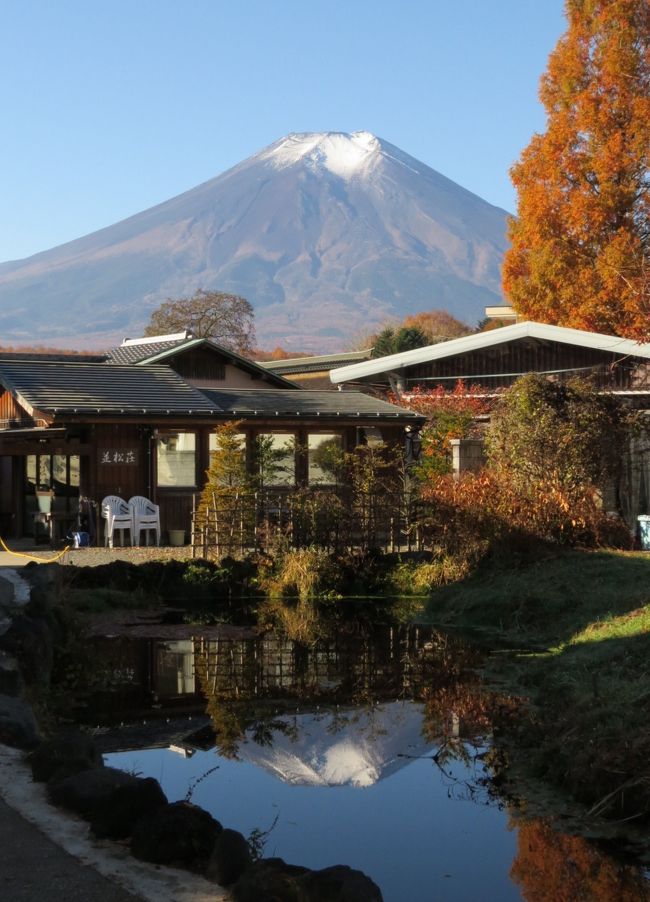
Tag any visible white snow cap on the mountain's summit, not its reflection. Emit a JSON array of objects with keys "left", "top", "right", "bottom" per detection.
[{"left": 261, "top": 132, "right": 381, "bottom": 179}]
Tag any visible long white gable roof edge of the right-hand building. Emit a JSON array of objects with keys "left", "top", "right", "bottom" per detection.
[{"left": 330, "top": 322, "right": 650, "bottom": 383}]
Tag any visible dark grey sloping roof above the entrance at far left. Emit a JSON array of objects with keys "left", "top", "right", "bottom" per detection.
[{"left": 0, "top": 358, "right": 218, "bottom": 416}]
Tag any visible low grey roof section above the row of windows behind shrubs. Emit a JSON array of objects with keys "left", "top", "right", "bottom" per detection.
[{"left": 203, "top": 388, "right": 424, "bottom": 421}]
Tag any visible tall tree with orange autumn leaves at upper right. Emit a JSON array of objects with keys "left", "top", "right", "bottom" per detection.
[{"left": 503, "top": 0, "right": 650, "bottom": 340}]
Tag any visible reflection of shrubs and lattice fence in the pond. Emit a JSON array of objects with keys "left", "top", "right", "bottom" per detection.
[{"left": 194, "top": 626, "right": 498, "bottom": 763}]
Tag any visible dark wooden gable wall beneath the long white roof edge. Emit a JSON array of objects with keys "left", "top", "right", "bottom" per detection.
[{"left": 405, "top": 338, "right": 650, "bottom": 390}]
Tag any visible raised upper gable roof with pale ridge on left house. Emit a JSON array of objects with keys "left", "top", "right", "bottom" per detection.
[{"left": 107, "top": 332, "right": 300, "bottom": 391}]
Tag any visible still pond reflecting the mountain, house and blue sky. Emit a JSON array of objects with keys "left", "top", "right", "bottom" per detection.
[{"left": 80, "top": 618, "right": 648, "bottom": 902}]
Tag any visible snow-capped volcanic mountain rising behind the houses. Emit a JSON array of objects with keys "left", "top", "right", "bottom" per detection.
[{"left": 0, "top": 132, "right": 507, "bottom": 351}]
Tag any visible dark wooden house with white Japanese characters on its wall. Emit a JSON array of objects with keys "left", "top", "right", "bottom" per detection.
[{"left": 0, "top": 333, "right": 421, "bottom": 537}]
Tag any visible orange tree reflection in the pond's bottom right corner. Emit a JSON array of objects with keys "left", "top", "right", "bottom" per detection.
[{"left": 510, "top": 820, "right": 650, "bottom": 902}]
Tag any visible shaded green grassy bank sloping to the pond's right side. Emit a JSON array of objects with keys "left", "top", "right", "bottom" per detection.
[{"left": 425, "top": 551, "right": 650, "bottom": 844}]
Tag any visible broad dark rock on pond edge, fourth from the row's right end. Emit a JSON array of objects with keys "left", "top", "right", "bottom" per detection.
[{"left": 131, "top": 802, "right": 223, "bottom": 871}]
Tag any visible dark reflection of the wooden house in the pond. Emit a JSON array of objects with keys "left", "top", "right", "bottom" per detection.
[{"left": 91, "top": 626, "right": 480, "bottom": 734}]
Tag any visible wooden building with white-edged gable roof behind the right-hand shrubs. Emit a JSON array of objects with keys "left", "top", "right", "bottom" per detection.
[{"left": 330, "top": 322, "right": 650, "bottom": 526}]
